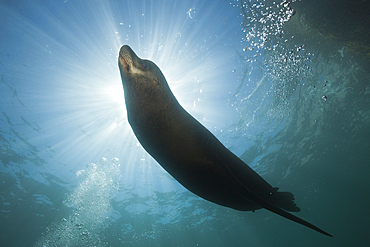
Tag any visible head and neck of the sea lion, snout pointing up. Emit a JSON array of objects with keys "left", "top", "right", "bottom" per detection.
[{"left": 118, "top": 45, "right": 178, "bottom": 125}]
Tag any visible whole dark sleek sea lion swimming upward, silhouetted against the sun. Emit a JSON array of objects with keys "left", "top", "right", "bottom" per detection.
[{"left": 118, "top": 45, "right": 331, "bottom": 236}]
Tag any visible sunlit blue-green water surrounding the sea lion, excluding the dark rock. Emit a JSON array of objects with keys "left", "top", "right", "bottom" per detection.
[{"left": 0, "top": 0, "right": 370, "bottom": 247}]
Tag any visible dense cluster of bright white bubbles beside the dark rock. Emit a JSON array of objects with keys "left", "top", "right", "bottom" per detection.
[{"left": 241, "top": 0, "right": 313, "bottom": 104}]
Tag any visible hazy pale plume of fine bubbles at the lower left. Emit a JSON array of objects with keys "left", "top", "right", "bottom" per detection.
[{"left": 34, "top": 158, "right": 120, "bottom": 247}]
